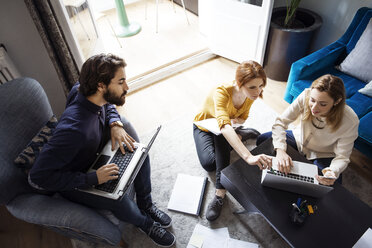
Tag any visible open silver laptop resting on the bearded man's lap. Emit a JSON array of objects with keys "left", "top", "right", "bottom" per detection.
[{"left": 79, "top": 126, "right": 161, "bottom": 200}]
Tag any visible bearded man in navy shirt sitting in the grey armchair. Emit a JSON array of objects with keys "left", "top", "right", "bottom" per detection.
[{"left": 29, "top": 54, "right": 175, "bottom": 247}]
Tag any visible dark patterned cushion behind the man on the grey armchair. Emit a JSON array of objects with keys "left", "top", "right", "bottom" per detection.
[{"left": 14, "top": 115, "right": 58, "bottom": 170}]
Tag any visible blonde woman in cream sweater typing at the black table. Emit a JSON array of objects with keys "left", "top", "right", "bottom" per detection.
[{"left": 257, "top": 74, "right": 359, "bottom": 185}]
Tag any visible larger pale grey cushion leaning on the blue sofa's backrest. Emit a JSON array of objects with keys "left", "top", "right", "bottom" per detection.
[{"left": 338, "top": 19, "right": 372, "bottom": 82}]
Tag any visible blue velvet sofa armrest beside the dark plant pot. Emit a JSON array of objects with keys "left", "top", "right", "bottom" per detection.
[{"left": 284, "top": 41, "right": 345, "bottom": 103}]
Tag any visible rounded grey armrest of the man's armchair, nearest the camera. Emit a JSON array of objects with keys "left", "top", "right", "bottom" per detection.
[{"left": 7, "top": 194, "right": 121, "bottom": 245}]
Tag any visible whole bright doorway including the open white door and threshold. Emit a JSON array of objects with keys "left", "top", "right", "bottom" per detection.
[{"left": 54, "top": 0, "right": 273, "bottom": 90}]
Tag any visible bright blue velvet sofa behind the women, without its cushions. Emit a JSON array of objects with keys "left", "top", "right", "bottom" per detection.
[{"left": 284, "top": 7, "right": 372, "bottom": 158}]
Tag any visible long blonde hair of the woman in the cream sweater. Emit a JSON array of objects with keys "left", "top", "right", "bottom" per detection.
[{"left": 302, "top": 74, "right": 346, "bottom": 132}]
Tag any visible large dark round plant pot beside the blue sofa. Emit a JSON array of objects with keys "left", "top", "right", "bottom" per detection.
[{"left": 264, "top": 7, "right": 322, "bottom": 81}]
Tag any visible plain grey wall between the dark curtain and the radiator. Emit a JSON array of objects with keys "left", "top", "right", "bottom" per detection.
[{"left": 0, "top": 0, "right": 66, "bottom": 116}]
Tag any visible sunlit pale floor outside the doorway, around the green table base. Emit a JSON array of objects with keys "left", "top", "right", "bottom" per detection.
[{"left": 62, "top": 0, "right": 207, "bottom": 79}]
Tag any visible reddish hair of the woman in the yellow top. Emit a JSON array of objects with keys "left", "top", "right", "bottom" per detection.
[{"left": 235, "top": 60, "right": 266, "bottom": 98}]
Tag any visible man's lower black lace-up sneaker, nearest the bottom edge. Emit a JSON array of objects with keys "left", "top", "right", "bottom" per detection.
[{"left": 140, "top": 222, "right": 176, "bottom": 247}]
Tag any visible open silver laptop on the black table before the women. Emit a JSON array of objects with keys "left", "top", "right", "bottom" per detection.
[{"left": 261, "top": 158, "right": 333, "bottom": 197}]
